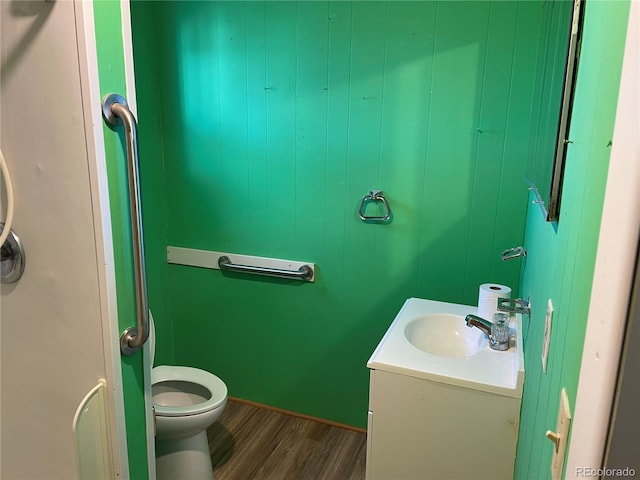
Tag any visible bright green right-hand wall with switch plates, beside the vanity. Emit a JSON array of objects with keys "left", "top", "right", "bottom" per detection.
[{"left": 516, "top": 1, "right": 629, "bottom": 479}]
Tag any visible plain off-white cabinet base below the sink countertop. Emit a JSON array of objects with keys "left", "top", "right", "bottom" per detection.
[{"left": 366, "top": 370, "right": 520, "bottom": 480}]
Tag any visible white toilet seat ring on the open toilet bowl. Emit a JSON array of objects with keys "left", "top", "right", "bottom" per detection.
[{"left": 151, "top": 366, "right": 227, "bottom": 417}]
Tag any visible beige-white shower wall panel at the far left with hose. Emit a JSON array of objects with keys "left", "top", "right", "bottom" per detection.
[{"left": 0, "top": 0, "right": 136, "bottom": 480}]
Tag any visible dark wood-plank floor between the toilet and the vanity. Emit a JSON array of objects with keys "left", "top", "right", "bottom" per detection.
[{"left": 207, "top": 400, "right": 366, "bottom": 480}]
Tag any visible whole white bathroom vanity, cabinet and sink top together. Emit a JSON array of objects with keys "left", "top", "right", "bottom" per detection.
[{"left": 366, "top": 298, "right": 524, "bottom": 480}]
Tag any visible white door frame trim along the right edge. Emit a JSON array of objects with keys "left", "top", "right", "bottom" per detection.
[{"left": 565, "top": 0, "right": 640, "bottom": 478}]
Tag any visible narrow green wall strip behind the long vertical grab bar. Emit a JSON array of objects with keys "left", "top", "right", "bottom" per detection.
[{"left": 93, "top": 1, "right": 149, "bottom": 480}]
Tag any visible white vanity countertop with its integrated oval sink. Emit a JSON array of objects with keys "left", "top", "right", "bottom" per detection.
[{"left": 367, "top": 298, "right": 524, "bottom": 398}]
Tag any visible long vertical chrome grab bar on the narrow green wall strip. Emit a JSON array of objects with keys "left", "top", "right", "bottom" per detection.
[{"left": 102, "top": 93, "right": 149, "bottom": 355}]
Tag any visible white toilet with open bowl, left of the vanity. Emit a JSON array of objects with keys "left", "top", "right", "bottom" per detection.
[{"left": 148, "top": 313, "right": 227, "bottom": 480}]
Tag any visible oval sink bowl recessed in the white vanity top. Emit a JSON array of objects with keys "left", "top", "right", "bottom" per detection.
[{"left": 404, "top": 313, "right": 488, "bottom": 358}]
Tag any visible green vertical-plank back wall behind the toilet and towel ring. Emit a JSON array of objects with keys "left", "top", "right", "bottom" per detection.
[{"left": 132, "top": 1, "right": 541, "bottom": 426}]
